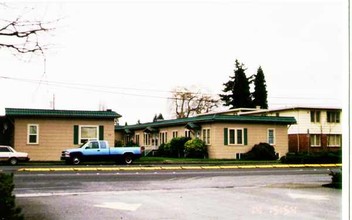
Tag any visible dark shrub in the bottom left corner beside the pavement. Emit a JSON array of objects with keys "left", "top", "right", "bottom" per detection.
[{"left": 0, "top": 173, "right": 23, "bottom": 219}]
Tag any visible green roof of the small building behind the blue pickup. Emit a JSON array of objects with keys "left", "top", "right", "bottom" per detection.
[{"left": 5, "top": 108, "right": 121, "bottom": 119}]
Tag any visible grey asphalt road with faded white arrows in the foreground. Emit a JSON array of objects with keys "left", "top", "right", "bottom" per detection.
[{"left": 8, "top": 168, "right": 342, "bottom": 220}]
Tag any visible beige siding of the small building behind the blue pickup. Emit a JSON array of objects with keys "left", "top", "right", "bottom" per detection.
[{"left": 14, "top": 118, "right": 115, "bottom": 161}]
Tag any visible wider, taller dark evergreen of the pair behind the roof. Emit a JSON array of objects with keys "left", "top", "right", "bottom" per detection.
[{"left": 220, "top": 60, "right": 253, "bottom": 109}]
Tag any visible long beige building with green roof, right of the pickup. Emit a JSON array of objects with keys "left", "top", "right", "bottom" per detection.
[{"left": 115, "top": 114, "right": 296, "bottom": 159}]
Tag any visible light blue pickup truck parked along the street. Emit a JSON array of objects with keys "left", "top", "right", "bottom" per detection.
[{"left": 61, "top": 140, "right": 142, "bottom": 165}]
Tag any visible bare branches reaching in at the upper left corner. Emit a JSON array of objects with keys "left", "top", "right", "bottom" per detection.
[{"left": 0, "top": 4, "right": 58, "bottom": 55}]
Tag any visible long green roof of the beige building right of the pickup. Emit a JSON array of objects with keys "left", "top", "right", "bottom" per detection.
[{"left": 115, "top": 114, "right": 296, "bottom": 130}]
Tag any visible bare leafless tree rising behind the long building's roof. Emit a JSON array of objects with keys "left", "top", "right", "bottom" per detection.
[{"left": 172, "top": 88, "right": 219, "bottom": 118}]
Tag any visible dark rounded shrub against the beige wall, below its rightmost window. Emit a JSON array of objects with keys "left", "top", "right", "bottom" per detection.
[{"left": 241, "top": 143, "right": 278, "bottom": 160}]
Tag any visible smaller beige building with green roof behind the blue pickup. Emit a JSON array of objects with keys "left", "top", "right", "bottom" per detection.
[{"left": 3, "top": 108, "right": 121, "bottom": 161}]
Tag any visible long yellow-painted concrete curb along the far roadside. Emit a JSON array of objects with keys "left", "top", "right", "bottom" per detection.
[{"left": 17, "top": 164, "right": 342, "bottom": 172}]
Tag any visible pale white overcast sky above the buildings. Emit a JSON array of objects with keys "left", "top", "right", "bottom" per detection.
[{"left": 0, "top": 0, "right": 349, "bottom": 124}]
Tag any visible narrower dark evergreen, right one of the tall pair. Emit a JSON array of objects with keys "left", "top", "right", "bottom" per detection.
[{"left": 252, "top": 67, "right": 268, "bottom": 109}]
